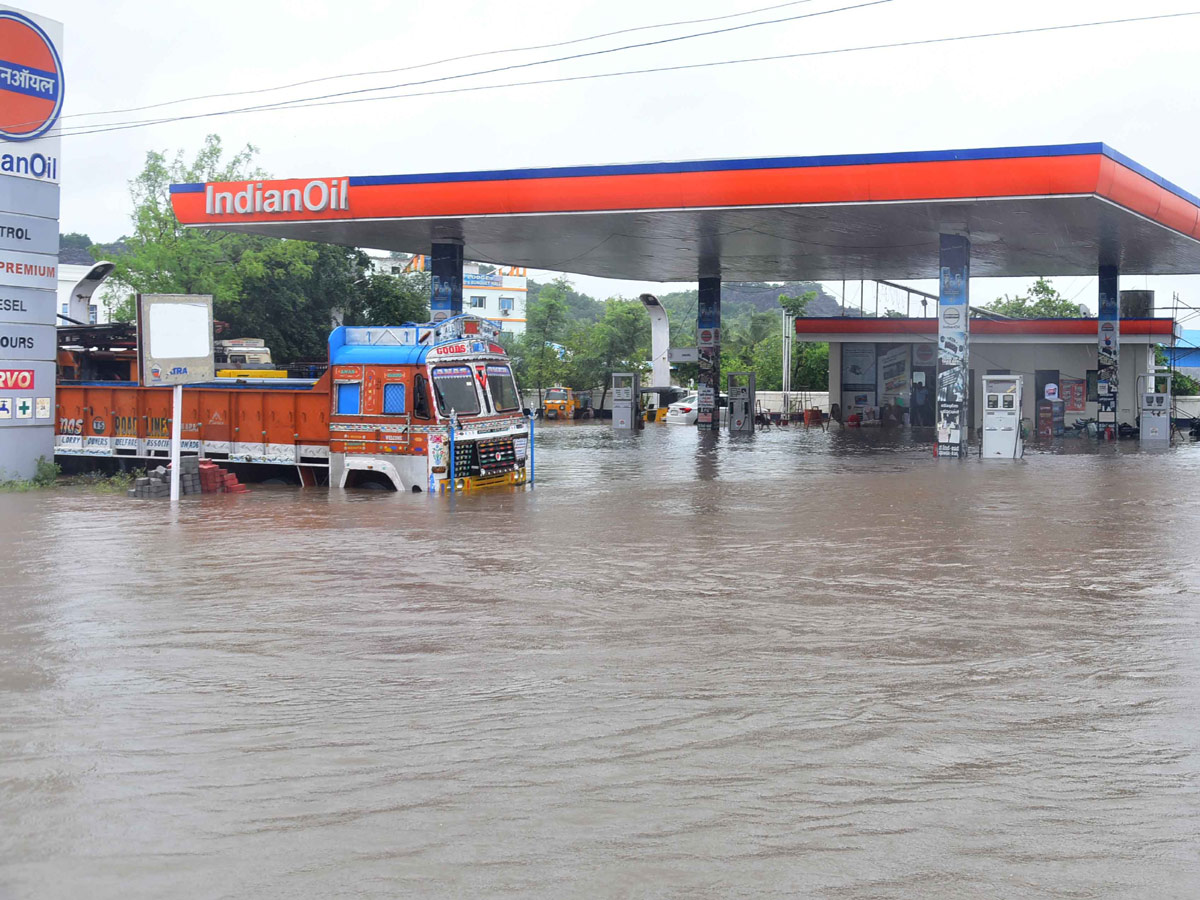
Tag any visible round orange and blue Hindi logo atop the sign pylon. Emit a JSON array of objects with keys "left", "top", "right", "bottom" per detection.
[{"left": 0, "top": 10, "right": 62, "bottom": 140}]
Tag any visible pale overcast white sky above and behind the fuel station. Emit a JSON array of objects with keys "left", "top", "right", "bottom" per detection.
[{"left": 28, "top": 0, "right": 1200, "bottom": 321}]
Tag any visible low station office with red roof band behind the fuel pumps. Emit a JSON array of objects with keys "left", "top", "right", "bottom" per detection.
[{"left": 796, "top": 317, "right": 1180, "bottom": 432}]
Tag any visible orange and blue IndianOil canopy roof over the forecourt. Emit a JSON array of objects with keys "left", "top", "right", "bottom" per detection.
[{"left": 172, "top": 144, "right": 1200, "bottom": 281}]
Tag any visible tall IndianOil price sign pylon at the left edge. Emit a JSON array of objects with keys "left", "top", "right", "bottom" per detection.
[{"left": 0, "top": 5, "right": 65, "bottom": 480}]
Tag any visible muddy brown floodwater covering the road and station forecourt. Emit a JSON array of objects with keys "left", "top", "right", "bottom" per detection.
[{"left": 0, "top": 425, "right": 1200, "bottom": 900}]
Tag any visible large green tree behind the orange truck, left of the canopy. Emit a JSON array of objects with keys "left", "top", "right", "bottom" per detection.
[{"left": 109, "top": 134, "right": 428, "bottom": 362}]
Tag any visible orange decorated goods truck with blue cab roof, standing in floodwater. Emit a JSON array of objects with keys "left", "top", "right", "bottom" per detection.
[{"left": 55, "top": 316, "right": 532, "bottom": 492}]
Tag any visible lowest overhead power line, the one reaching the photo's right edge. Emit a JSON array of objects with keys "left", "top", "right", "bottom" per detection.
[{"left": 64, "top": 8, "right": 1200, "bottom": 137}]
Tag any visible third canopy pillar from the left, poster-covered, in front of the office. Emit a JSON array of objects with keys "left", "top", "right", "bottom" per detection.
[{"left": 937, "top": 234, "right": 971, "bottom": 460}]
